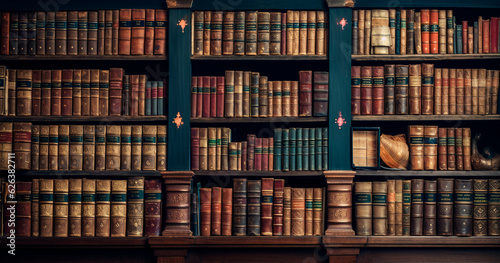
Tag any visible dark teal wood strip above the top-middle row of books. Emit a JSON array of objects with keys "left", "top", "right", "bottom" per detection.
[{"left": 192, "top": 0, "right": 326, "bottom": 10}]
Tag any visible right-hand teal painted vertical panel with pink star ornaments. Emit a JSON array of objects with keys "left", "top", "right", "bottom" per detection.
[{"left": 328, "top": 8, "right": 352, "bottom": 170}]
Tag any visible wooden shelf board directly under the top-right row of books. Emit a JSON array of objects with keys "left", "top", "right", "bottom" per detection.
[{"left": 351, "top": 54, "right": 500, "bottom": 61}]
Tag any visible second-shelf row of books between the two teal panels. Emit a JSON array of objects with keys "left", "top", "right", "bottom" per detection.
[{"left": 191, "top": 70, "right": 329, "bottom": 117}]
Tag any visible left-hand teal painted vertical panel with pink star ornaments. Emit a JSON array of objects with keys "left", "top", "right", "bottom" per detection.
[{"left": 167, "top": 9, "right": 191, "bottom": 171}]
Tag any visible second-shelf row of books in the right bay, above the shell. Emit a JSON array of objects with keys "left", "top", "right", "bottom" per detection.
[{"left": 351, "top": 64, "right": 500, "bottom": 115}]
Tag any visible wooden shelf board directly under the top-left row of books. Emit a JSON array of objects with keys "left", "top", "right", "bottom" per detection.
[{"left": 0, "top": 55, "right": 167, "bottom": 61}]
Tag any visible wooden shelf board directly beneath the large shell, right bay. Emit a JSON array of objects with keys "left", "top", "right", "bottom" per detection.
[{"left": 356, "top": 170, "right": 500, "bottom": 177}]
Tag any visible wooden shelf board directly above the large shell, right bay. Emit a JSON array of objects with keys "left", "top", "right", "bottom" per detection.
[{"left": 352, "top": 114, "right": 500, "bottom": 121}]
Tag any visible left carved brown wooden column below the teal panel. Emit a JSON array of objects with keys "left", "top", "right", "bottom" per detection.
[{"left": 162, "top": 171, "right": 194, "bottom": 236}]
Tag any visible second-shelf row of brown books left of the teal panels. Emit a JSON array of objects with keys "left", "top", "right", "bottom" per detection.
[{"left": 0, "top": 66, "right": 167, "bottom": 116}]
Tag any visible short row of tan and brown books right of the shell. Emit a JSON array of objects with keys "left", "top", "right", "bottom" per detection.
[{"left": 408, "top": 125, "right": 472, "bottom": 171}]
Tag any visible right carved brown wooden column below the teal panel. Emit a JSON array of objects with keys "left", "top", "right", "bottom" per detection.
[{"left": 324, "top": 171, "right": 356, "bottom": 236}]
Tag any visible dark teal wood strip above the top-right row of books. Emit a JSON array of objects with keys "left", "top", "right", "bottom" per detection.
[{"left": 354, "top": 0, "right": 500, "bottom": 8}]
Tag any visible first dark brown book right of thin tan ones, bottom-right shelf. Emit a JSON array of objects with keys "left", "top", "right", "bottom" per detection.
[{"left": 410, "top": 179, "right": 424, "bottom": 236}]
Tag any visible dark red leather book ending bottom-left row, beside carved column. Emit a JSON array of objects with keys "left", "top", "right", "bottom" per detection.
[{"left": 144, "top": 179, "right": 162, "bottom": 236}]
